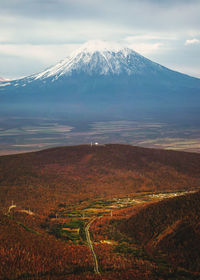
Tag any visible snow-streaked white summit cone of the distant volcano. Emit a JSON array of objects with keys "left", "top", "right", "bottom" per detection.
[{"left": 31, "top": 41, "right": 161, "bottom": 81}]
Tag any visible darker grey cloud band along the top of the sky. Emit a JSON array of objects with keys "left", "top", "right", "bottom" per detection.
[{"left": 1, "top": 0, "right": 200, "bottom": 28}]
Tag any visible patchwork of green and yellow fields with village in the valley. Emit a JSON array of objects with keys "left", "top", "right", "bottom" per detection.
[{"left": 42, "top": 191, "right": 192, "bottom": 244}]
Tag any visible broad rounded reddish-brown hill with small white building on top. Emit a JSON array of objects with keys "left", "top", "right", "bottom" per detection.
[{"left": 0, "top": 145, "right": 200, "bottom": 214}]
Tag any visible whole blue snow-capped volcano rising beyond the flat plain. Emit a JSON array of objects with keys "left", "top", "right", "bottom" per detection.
[{"left": 0, "top": 42, "right": 200, "bottom": 119}]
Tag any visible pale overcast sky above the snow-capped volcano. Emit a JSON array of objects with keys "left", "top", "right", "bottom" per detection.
[{"left": 0, "top": 0, "right": 200, "bottom": 78}]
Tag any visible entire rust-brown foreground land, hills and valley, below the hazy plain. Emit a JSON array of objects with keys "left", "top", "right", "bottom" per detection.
[{"left": 0, "top": 144, "right": 200, "bottom": 280}]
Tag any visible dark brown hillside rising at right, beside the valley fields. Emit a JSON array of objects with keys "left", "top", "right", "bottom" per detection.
[{"left": 119, "top": 192, "right": 200, "bottom": 272}]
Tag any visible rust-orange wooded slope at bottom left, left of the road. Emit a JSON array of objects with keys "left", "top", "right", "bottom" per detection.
[{"left": 0, "top": 215, "right": 93, "bottom": 279}]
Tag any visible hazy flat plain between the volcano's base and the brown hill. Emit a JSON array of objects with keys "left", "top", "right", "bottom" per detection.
[{"left": 0, "top": 117, "right": 200, "bottom": 155}]
